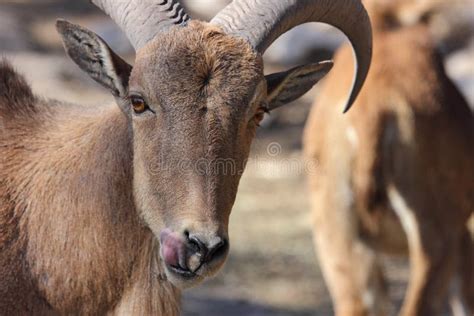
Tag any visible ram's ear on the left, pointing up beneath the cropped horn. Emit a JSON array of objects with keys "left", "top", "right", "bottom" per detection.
[{"left": 56, "top": 20, "right": 132, "bottom": 98}]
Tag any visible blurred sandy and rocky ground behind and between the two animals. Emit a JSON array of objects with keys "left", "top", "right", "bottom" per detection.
[{"left": 0, "top": 0, "right": 474, "bottom": 316}]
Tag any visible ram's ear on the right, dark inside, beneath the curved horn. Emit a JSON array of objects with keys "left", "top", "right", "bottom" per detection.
[{"left": 265, "top": 61, "right": 333, "bottom": 110}]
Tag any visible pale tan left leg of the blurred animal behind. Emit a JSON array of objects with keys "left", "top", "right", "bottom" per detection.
[{"left": 313, "top": 189, "right": 388, "bottom": 316}]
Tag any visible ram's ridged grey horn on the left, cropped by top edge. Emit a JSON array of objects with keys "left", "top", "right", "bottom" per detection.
[{"left": 91, "top": 0, "right": 190, "bottom": 50}]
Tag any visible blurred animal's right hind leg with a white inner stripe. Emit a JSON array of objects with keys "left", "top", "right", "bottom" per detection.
[{"left": 388, "top": 187, "right": 459, "bottom": 316}]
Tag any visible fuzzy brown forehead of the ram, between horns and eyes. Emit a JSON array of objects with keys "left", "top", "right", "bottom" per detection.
[{"left": 131, "top": 21, "right": 263, "bottom": 110}]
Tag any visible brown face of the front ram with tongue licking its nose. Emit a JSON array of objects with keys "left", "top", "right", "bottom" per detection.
[{"left": 128, "top": 22, "right": 267, "bottom": 287}]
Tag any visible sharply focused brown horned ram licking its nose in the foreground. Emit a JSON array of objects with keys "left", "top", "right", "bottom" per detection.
[{"left": 0, "top": 0, "right": 372, "bottom": 316}]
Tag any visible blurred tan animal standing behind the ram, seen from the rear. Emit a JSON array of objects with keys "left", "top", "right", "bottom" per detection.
[{"left": 304, "top": 0, "right": 474, "bottom": 316}]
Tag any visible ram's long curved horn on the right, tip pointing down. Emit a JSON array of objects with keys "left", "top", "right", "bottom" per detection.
[{"left": 211, "top": 0, "right": 372, "bottom": 112}]
